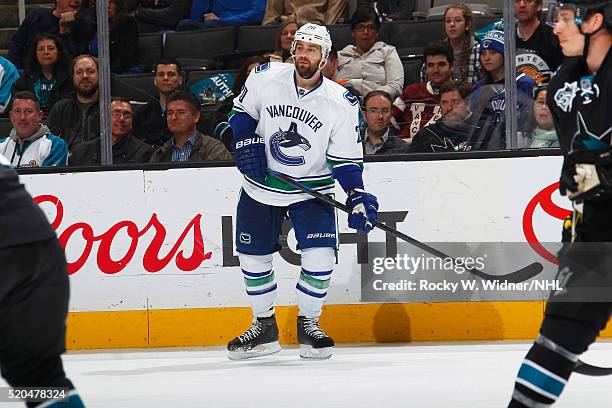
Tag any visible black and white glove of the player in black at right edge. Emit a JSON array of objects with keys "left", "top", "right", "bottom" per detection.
[{"left": 568, "top": 150, "right": 612, "bottom": 201}]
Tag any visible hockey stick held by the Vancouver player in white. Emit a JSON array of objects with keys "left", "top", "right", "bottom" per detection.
[{"left": 268, "top": 169, "right": 543, "bottom": 283}]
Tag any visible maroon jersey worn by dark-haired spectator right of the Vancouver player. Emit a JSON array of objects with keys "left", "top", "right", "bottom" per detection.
[{"left": 393, "top": 81, "right": 442, "bottom": 139}]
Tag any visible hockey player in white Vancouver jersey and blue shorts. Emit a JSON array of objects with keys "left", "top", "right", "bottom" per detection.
[{"left": 228, "top": 24, "right": 378, "bottom": 359}]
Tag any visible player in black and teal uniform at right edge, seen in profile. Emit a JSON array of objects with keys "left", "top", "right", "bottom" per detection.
[{"left": 509, "top": 1, "right": 612, "bottom": 408}]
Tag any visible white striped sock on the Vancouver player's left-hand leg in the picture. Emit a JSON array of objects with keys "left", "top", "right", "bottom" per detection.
[{"left": 238, "top": 254, "right": 276, "bottom": 317}]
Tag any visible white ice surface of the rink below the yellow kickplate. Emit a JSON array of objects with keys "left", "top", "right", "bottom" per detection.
[{"left": 0, "top": 342, "right": 612, "bottom": 408}]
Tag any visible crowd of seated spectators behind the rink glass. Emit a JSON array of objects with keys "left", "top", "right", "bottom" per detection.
[{"left": 0, "top": 0, "right": 563, "bottom": 167}]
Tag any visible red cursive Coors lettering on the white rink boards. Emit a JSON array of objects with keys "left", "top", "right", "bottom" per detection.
[{"left": 34, "top": 195, "right": 212, "bottom": 275}]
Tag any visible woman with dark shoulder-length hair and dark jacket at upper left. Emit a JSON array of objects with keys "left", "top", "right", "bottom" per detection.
[{"left": 13, "top": 34, "right": 73, "bottom": 113}]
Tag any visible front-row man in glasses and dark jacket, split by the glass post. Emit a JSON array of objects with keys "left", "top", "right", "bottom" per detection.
[{"left": 70, "top": 96, "right": 153, "bottom": 166}]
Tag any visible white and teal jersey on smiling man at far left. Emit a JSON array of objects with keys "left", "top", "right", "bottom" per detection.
[{"left": 0, "top": 125, "right": 68, "bottom": 167}]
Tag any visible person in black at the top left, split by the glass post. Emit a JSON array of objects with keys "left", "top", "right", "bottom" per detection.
[{"left": 89, "top": 0, "right": 139, "bottom": 74}]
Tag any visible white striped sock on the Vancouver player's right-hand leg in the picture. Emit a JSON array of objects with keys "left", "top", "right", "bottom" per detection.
[{"left": 296, "top": 248, "right": 335, "bottom": 317}]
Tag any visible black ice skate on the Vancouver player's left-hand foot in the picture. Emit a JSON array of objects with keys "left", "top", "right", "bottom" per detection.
[{"left": 227, "top": 315, "right": 281, "bottom": 360}]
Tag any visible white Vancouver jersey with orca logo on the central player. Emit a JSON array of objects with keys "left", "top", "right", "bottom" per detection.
[{"left": 234, "top": 62, "right": 363, "bottom": 206}]
